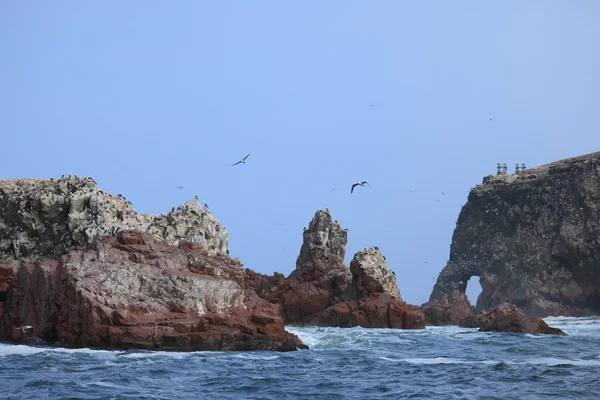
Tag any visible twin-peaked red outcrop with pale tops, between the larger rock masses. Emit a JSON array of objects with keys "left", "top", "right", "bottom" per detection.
[{"left": 246, "top": 210, "right": 425, "bottom": 329}]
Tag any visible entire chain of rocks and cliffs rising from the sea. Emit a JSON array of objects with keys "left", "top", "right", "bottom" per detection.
[{"left": 0, "top": 153, "right": 600, "bottom": 351}]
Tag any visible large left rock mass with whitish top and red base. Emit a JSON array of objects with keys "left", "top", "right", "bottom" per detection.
[{"left": 0, "top": 178, "right": 306, "bottom": 351}]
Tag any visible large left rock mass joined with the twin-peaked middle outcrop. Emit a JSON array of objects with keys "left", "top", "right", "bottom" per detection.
[{"left": 0, "top": 177, "right": 425, "bottom": 351}]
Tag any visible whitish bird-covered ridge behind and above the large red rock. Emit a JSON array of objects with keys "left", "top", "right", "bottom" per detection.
[{"left": 0, "top": 177, "right": 229, "bottom": 260}]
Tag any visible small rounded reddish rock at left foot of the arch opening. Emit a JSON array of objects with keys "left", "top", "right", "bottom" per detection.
[{"left": 421, "top": 290, "right": 473, "bottom": 325}]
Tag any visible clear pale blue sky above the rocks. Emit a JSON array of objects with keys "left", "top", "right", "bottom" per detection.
[{"left": 0, "top": 0, "right": 600, "bottom": 304}]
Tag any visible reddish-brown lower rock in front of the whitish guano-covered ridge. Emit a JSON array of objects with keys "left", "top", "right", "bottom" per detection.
[{"left": 0, "top": 231, "right": 306, "bottom": 351}]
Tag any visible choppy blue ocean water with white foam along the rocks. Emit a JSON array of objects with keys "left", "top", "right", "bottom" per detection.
[{"left": 0, "top": 317, "right": 600, "bottom": 400}]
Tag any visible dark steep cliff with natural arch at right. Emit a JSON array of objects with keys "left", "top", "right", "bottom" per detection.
[{"left": 430, "top": 153, "right": 600, "bottom": 317}]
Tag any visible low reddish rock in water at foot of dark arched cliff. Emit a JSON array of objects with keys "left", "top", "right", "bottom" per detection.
[{"left": 460, "top": 303, "right": 567, "bottom": 336}]
